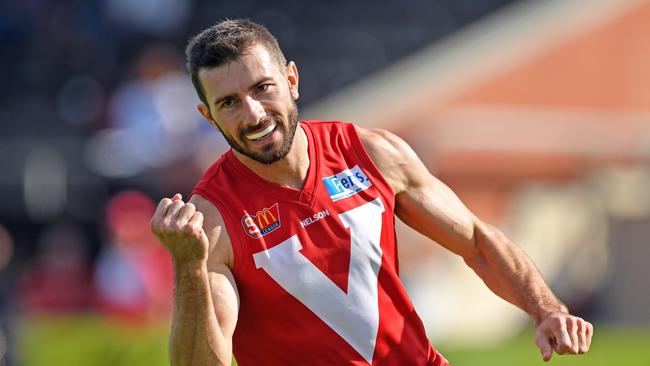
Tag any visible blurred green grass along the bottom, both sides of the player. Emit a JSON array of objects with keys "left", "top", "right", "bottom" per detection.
[{"left": 12, "top": 316, "right": 650, "bottom": 366}]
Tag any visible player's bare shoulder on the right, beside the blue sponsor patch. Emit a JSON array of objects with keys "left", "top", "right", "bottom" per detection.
[{"left": 356, "top": 126, "right": 426, "bottom": 194}]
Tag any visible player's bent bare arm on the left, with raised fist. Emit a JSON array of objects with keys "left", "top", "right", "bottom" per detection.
[{"left": 151, "top": 194, "right": 239, "bottom": 366}]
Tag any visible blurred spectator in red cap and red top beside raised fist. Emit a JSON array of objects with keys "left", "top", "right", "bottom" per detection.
[{"left": 95, "top": 191, "right": 173, "bottom": 321}]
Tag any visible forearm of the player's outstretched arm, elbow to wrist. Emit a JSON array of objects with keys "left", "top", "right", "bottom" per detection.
[{"left": 464, "top": 222, "right": 567, "bottom": 324}]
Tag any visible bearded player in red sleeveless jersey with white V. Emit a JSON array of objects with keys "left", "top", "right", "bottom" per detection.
[{"left": 151, "top": 20, "right": 593, "bottom": 366}]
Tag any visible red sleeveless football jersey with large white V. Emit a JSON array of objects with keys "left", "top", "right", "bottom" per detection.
[{"left": 192, "top": 121, "right": 448, "bottom": 366}]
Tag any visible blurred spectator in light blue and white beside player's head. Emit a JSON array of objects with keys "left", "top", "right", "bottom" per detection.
[{"left": 87, "top": 44, "right": 218, "bottom": 178}]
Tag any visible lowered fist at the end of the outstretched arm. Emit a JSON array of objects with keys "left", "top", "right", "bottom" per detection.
[{"left": 535, "top": 312, "right": 594, "bottom": 361}]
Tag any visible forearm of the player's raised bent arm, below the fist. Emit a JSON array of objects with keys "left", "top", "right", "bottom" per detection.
[{"left": 169, "top": 265, "right": 232, "bottom": 366}]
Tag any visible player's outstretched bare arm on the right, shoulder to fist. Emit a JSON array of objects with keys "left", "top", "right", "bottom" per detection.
[{"left": 358, "top": 128, "right": 593, "bottom": 361}]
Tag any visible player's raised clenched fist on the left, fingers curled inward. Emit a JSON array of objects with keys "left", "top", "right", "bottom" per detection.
[{"left": 151, "top": 193, "right": 208, "bottom": 266}]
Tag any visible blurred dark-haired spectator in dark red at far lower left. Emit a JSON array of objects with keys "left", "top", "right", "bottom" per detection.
[{"left": 17, "top": 223, "right": 93, "bottom": 314}]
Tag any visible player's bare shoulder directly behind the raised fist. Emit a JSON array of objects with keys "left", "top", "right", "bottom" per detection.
[{"left": 189, "top": 194, "right": 233, "bottom": 269}]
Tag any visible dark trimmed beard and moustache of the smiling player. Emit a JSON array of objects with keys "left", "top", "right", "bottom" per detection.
[{"left": 219, "top": 102, "right": 298, "bottom": 165}]
